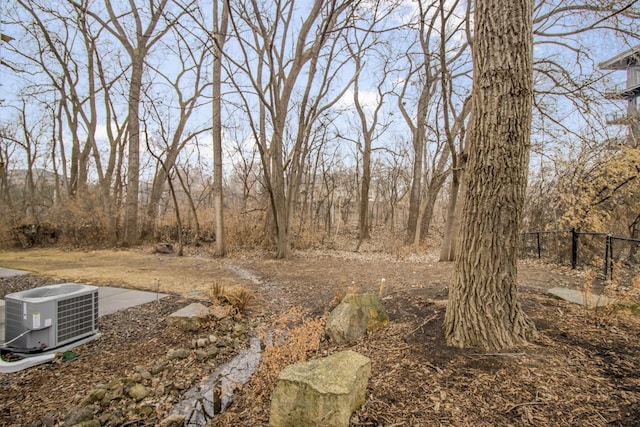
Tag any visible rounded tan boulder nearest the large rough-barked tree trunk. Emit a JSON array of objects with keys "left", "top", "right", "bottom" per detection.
[{"left": 325, "top": 294, "right": 389, "bottom": 344}]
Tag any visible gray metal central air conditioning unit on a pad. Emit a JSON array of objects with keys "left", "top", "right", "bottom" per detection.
[{"left": 5, "top": 283, "right": 98, "bottom": 352}]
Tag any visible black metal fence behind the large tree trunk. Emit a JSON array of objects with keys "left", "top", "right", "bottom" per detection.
[{"left": 520, "top": 229, "right": 640, "bottom": 284}]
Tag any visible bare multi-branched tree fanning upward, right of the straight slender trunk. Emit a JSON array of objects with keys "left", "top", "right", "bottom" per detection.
[{"left": 229, "top": 0, "right": 353, "bottom": 258}]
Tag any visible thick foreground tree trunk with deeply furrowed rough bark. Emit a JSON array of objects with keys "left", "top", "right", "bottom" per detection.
[{"left": 444, "top": 0, "right": 536, "bottom": 350}]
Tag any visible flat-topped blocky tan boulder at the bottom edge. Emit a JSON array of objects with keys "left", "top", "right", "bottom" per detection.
[{"left": 269, "top": 350, "right": 371, "bottom": 427}]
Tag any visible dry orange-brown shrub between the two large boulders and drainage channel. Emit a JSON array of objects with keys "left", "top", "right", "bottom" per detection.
[{"left": 248, "top": 307, "right": 326, "bottom": 402}]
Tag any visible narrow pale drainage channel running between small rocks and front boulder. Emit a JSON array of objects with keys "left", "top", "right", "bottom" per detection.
[{"left": 171, "top": 337, "right": 261, "bottom": 427}]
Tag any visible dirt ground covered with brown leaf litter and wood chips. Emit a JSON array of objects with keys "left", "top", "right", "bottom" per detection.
[{"left": 0, "top": 248, "right": 640, "bottom": 427}]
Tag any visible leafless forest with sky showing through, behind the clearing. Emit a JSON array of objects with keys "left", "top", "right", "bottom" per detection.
[{"left": 0, "top": 0, "right": 640, "bottom": 260}]
